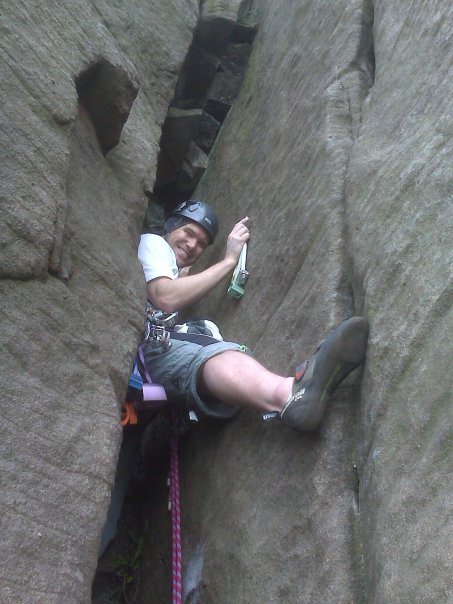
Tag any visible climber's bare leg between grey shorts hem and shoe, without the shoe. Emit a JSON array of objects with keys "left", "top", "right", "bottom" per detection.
[{"left": 199, "top": 350, "right": 293, "bottom": 412}]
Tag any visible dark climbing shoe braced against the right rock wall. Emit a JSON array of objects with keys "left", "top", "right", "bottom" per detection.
[{"left": 280, "top": 317, "right": 368, "bottom": 432}]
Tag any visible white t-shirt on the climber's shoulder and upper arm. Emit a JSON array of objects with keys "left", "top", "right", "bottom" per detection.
[{"left": 138, "top": 233, "right": 179, "bottom": 282}]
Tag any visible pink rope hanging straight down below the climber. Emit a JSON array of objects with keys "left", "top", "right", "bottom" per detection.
[{"left": 170, "top": 410, "right": 182, "bottom": 604}]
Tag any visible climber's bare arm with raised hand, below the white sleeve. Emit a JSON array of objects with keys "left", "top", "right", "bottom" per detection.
[{"left": 146, "top": 218, "right": 250, "bottom": 312}]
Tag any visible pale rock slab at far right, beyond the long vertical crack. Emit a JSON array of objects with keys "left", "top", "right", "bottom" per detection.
[{"left": 345, "top": 2, "right": 453, "bottom": 602}]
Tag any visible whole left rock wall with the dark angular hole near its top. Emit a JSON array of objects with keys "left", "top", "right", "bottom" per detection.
[{"left": 0, "top": 0, "right": 199, "bottom": 604}]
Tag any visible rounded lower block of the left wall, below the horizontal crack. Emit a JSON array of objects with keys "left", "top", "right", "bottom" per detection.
[{"left": 0, "top": 277, "right": 121, "bottom": 604}]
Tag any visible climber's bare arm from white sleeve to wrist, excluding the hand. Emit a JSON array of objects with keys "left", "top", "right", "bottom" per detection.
[{"left": 146, "top": 257, "right": 236, "bottom": 312}]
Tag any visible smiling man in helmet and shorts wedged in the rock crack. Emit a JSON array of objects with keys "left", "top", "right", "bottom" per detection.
[{"left": 138, "top": 200, "right": 368, "bottom": 432}]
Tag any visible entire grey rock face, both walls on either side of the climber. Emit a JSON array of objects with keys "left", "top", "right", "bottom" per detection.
[{"left": 0, "top": 0, "right": 453, "bottom": 604}]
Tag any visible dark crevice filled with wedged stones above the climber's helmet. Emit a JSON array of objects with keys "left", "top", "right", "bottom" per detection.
[{"left": 151, "top": 2, "right": 256, "bottom": 210}]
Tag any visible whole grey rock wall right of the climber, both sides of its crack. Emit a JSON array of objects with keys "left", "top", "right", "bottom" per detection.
[{"left": 135, "top": 0, "right": 453, "bottom": 604}]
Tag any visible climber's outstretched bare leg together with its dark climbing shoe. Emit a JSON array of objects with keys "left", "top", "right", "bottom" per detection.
[{"left": 200, "top": 317, "right": 368, "bottom": 432}]
